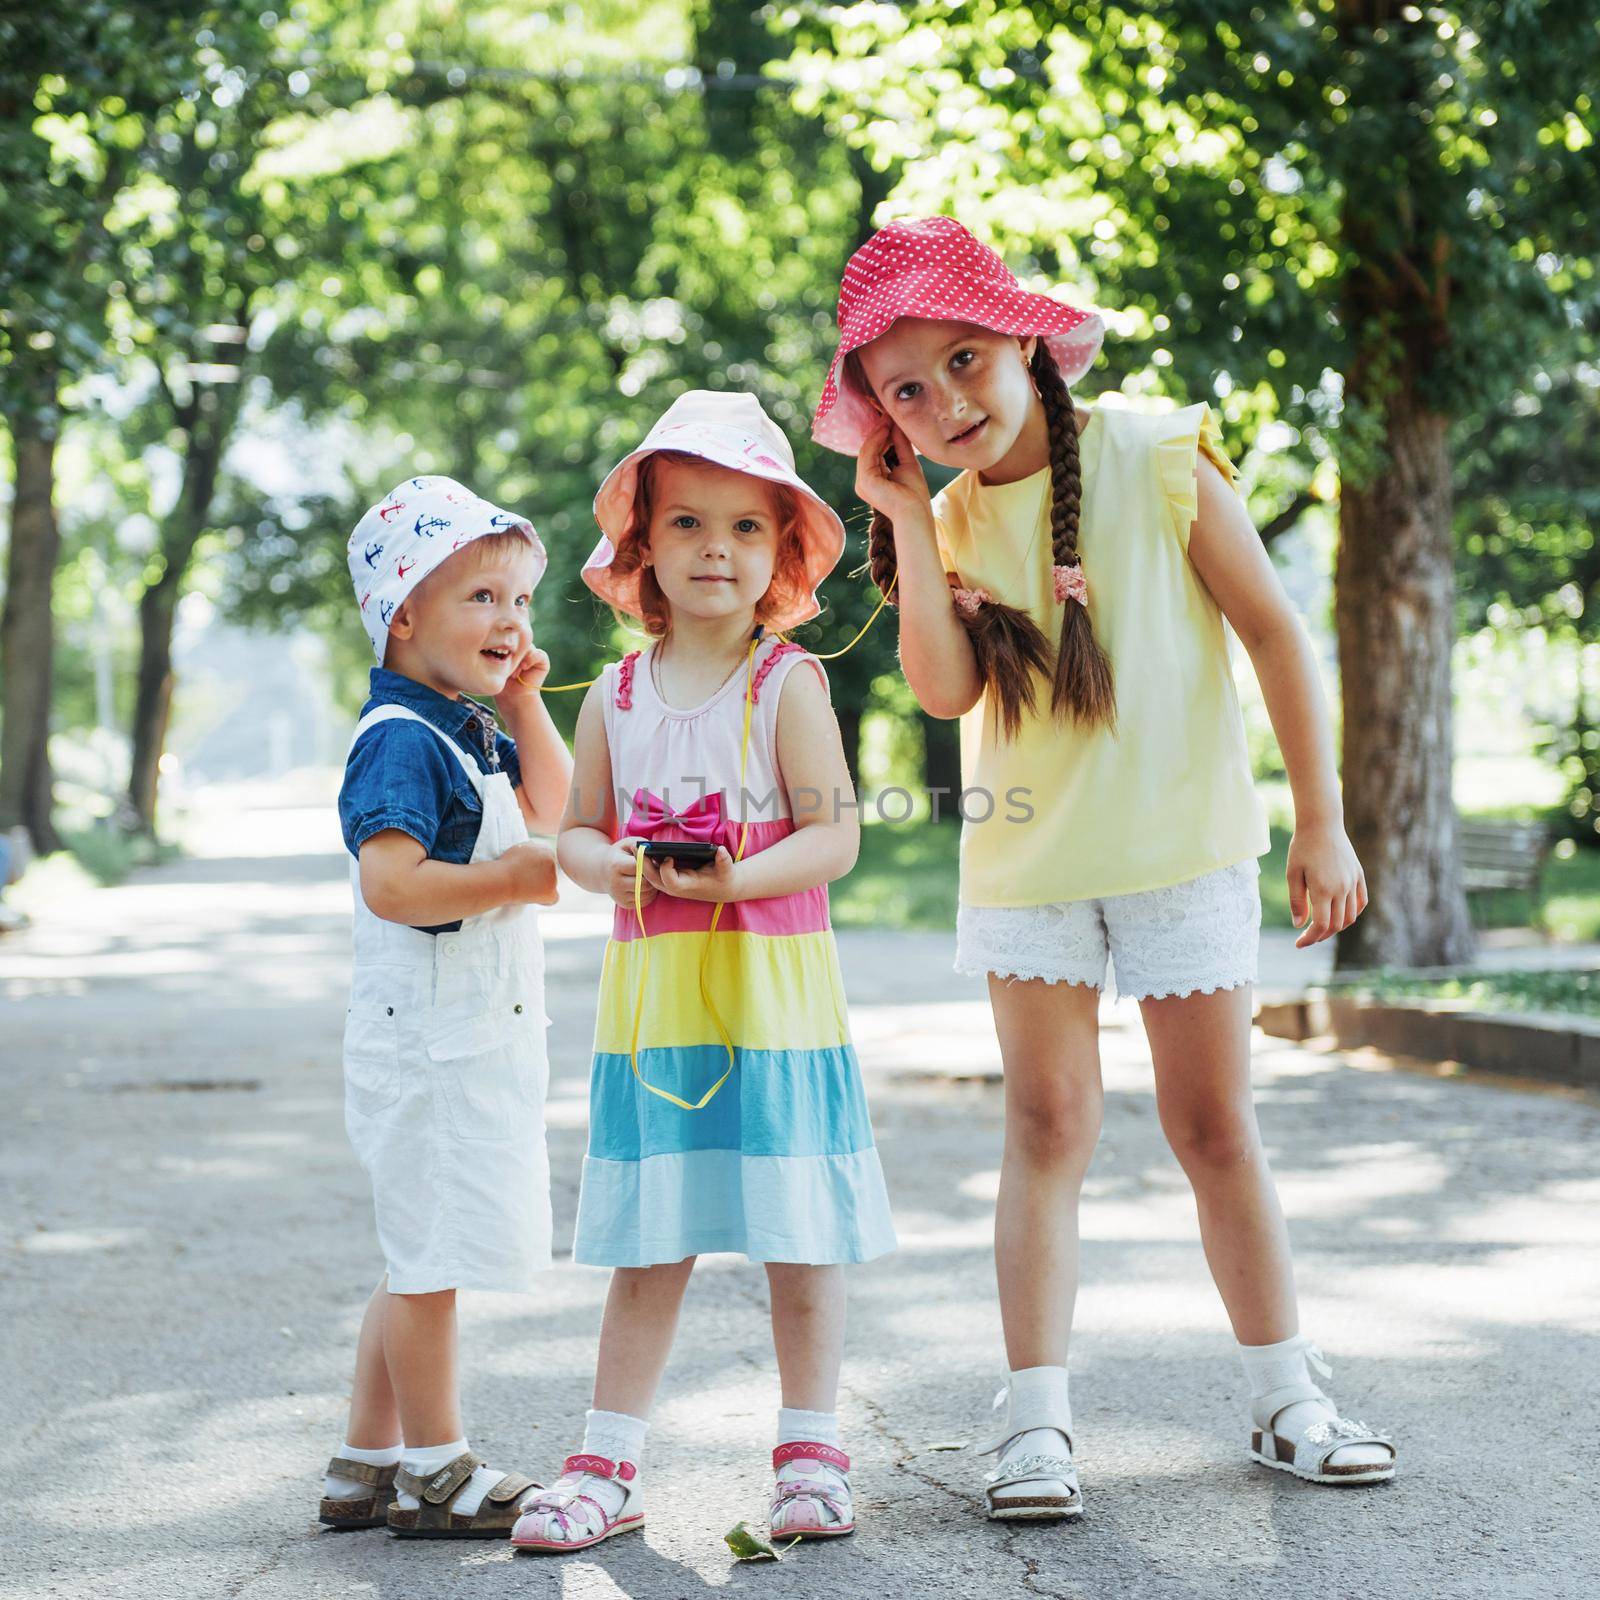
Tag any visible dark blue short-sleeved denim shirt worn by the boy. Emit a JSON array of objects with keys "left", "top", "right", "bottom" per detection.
[{"left": 339, "top": 667, "right": 522, "bottom": 933}]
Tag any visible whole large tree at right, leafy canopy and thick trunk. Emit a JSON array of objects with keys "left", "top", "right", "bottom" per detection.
[{"left": 794, "top": 0, "right": 1600, "bottom": 965}]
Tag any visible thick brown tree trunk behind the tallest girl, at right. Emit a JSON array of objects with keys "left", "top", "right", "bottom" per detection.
[{"left": 1334, "top": 373, "right": 1474, "bottom": 968}]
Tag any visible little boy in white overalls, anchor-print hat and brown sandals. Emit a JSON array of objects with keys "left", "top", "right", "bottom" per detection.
[{"left": 320, "top": 477, "right": 571, "bottom": 1539}]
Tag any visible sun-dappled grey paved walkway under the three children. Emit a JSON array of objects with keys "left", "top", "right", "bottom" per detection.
[{"left": 0, "top": 784, "right": 1600, "bottom": 1600}]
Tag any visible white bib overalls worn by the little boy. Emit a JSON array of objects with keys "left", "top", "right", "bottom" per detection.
[{"left": 344, "top": 706, "right": 550, "bottom": 1294}]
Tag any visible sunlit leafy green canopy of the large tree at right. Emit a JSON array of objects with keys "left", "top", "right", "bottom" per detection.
[{"left": 794, "top": 0, "right": 1600, "bottom": 477}]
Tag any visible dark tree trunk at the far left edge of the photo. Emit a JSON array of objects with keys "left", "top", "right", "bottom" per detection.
[{"left": 0, "top": 388, "right": 61, "bottom": 854}]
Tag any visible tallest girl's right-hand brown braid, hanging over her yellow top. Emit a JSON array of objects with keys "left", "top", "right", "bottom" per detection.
[{"left": 1032, "top": 339, "right": 1117, "bottom": 726}]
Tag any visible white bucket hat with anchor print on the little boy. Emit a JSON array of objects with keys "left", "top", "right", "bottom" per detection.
[{"left": 347, "top": 475, "right": 549, "bottom": 666}]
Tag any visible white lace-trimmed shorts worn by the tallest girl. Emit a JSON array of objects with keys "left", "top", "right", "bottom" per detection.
[{"left": 955, "top": 861, "right": 1261, "bottom": 1000}]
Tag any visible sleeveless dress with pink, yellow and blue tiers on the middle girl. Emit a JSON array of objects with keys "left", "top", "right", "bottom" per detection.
[{"left": 573, "top": 637, "right": 894, "bottom": 1267}]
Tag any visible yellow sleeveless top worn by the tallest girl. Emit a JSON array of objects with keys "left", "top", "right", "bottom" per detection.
[{"left": 933, "top": 405, "right": 1269, "bottom": 906}]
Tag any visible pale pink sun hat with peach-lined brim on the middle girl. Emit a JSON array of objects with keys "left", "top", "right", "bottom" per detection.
[{"left": 582, "top": 389, "right": 845, "bottom": 634}]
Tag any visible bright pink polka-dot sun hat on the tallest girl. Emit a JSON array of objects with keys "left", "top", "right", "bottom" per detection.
[{"left": 811, "top": 216, "right": 1106, "bottom": 456}]
